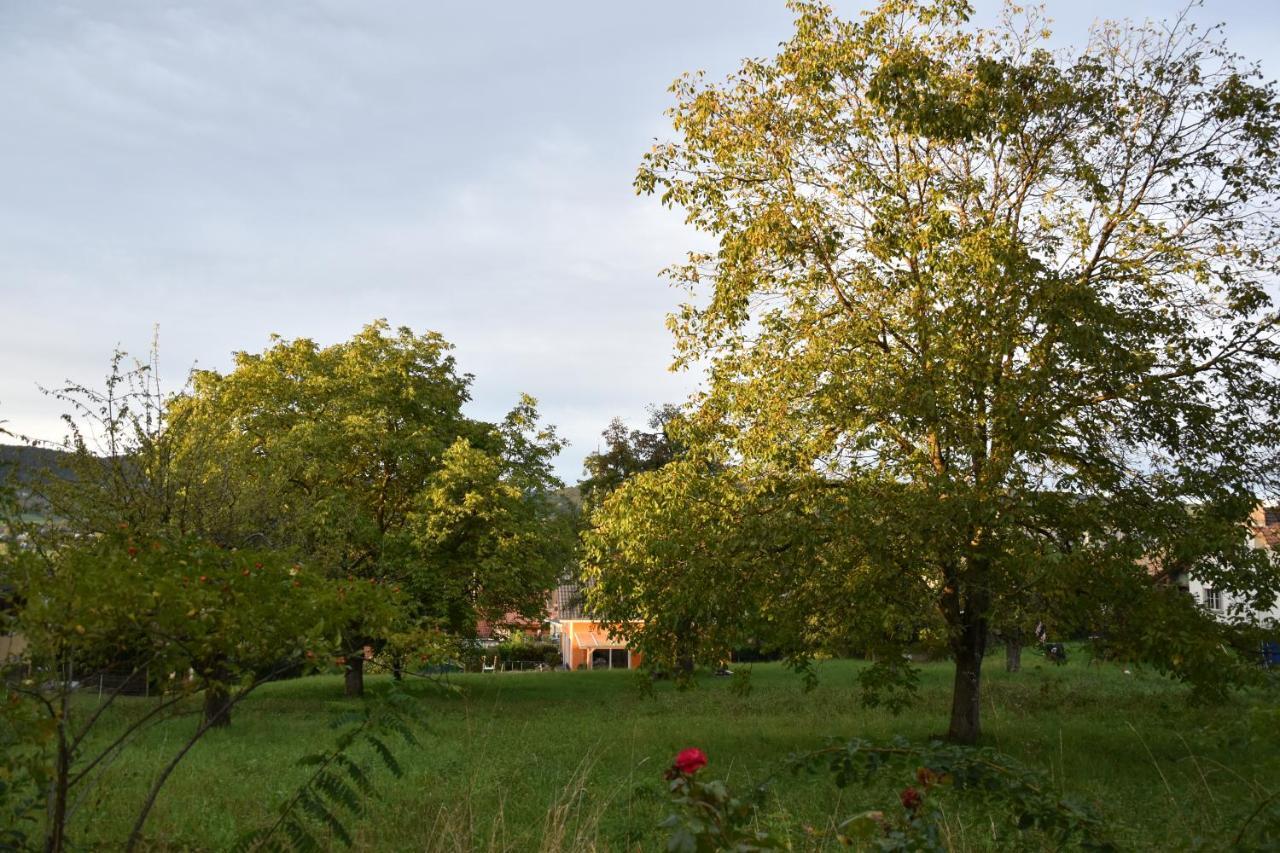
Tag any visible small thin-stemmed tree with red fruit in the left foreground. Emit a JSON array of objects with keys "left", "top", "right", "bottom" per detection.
[{"left": 0, "top": 504, "right": 397, "bottom": 850}]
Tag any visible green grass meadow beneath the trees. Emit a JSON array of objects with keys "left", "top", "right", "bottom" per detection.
[{"left": 74, "top": 654, "right": 1280, "bottom": 850}]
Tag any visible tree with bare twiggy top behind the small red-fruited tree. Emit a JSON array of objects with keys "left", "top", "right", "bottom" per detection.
[{"left": 20, "top": 347, "right": 340, "bottom": 727}]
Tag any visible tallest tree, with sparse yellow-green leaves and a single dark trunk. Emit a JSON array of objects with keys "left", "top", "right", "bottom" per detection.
[{"left": 596, "top": 0, "right": 1280, "bottom": 742}]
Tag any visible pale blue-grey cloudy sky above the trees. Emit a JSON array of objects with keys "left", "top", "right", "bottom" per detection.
[{"left": 0, "top": 0, "right": 1280, "bottom": 482}]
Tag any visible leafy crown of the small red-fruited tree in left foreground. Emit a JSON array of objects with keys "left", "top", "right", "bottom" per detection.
[{"left": 14, "top": 530, "right": 396, "bottom": 679}]
